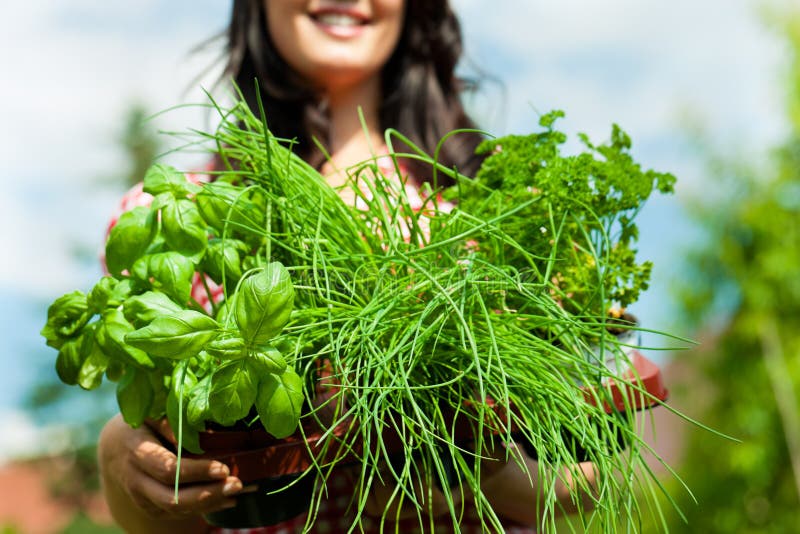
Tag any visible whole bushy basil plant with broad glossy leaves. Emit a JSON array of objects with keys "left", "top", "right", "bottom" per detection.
[{"left": 41, "top": 165, "right": 304, "bottom": 453}]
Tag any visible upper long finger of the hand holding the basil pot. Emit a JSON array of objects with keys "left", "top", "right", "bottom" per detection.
[{"left": 133, "top": 437, "right": 230, "bottom": 485}]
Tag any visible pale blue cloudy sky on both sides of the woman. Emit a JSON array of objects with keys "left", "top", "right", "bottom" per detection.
[{"left": 0, "top": 0, "right": 784, "bottom": 460}]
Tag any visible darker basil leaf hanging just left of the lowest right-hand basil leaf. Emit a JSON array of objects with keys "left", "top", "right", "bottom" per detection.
[{"left": 208, "top": 359, "right": 258, "bottom": 426}]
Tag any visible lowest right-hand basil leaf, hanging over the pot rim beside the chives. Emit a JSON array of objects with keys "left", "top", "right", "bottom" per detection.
[{"left": 256, "top": 369, "right": 304, "bottom": 439}]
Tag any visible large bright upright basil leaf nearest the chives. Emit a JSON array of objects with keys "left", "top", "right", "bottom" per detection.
[{"left": 234, "top": 262, "right": 294, "bottom": 346}]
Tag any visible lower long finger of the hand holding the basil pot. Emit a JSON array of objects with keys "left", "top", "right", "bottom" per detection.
[{"left": 134, "top": 474, "right": 242, "bottom": 516}]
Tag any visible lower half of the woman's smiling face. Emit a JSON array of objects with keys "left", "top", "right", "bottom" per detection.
[{"left": 264, "top": 0, "right": 405, "bottom": 91}]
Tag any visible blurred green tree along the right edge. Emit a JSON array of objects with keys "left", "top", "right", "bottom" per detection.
[{"left": 670, "top": 8, "right": 800, "bottom": 534}]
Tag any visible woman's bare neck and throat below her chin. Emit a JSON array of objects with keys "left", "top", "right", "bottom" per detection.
[{"left": 322, "top": 78, "right": 383, "bottom": 185}]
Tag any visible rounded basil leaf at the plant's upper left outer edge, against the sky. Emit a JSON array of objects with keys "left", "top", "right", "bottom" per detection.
[{"left": 106, "top": 206, "right": 158, "bottom": 276}]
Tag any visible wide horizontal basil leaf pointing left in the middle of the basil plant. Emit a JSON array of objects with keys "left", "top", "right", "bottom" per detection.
[{"left": 125, "top": 310, "right": 219, "bottom": 360}]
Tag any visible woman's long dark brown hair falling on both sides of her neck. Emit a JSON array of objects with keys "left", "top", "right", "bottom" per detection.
[{"left": 223, "top": 0, "right": 481, "bottom": 186}]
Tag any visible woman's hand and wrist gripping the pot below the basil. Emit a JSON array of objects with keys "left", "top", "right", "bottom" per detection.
[{"left": 98, "top": 416, "right": 250, "bottom": 534}]
